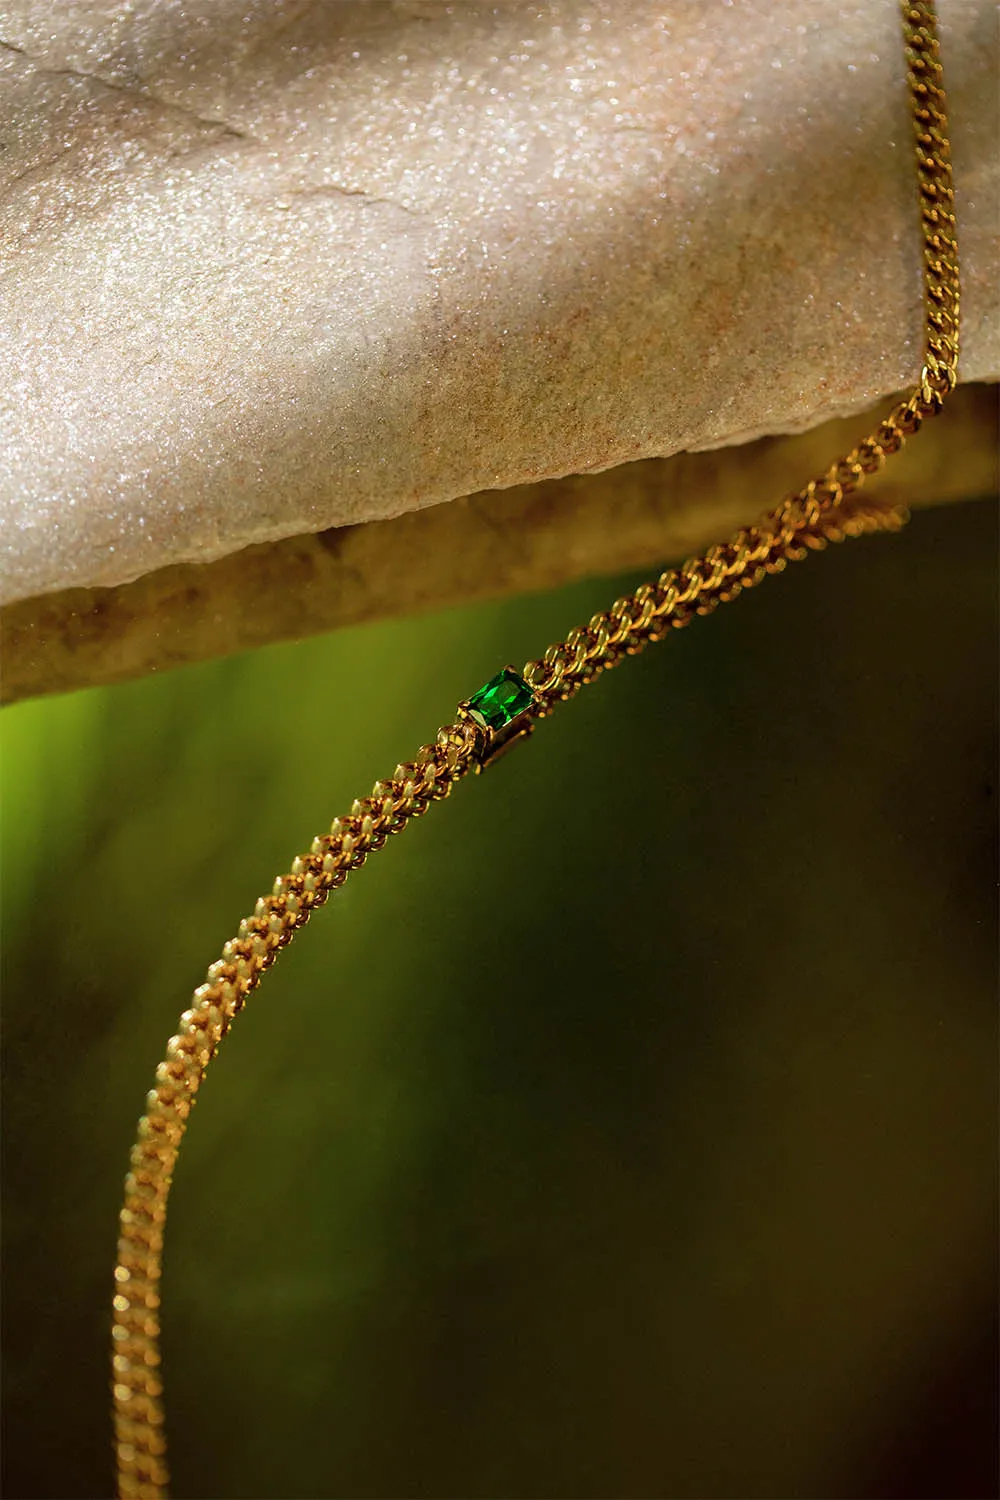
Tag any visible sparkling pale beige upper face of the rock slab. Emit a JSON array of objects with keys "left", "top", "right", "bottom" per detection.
[{"left": 0, "top": 0, "right": 1000, "bottom": 600}]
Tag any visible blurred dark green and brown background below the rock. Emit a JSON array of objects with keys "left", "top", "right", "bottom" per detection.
[{"left": 0, "top": 503, "right": 997, "bottom": 1500}]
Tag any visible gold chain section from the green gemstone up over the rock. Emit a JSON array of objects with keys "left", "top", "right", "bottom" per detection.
[{"left": 523, "top": 0, "right": 960, "bottom": 716}]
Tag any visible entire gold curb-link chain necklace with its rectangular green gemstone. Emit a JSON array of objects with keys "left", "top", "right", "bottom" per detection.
[{"left": 112, "top": 0, "right": 960, "bottom": 1500}]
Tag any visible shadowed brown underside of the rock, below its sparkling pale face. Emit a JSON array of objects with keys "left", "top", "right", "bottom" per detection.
[{"left": 0, "top": 386, "right": 999, "bottom": 702}]
